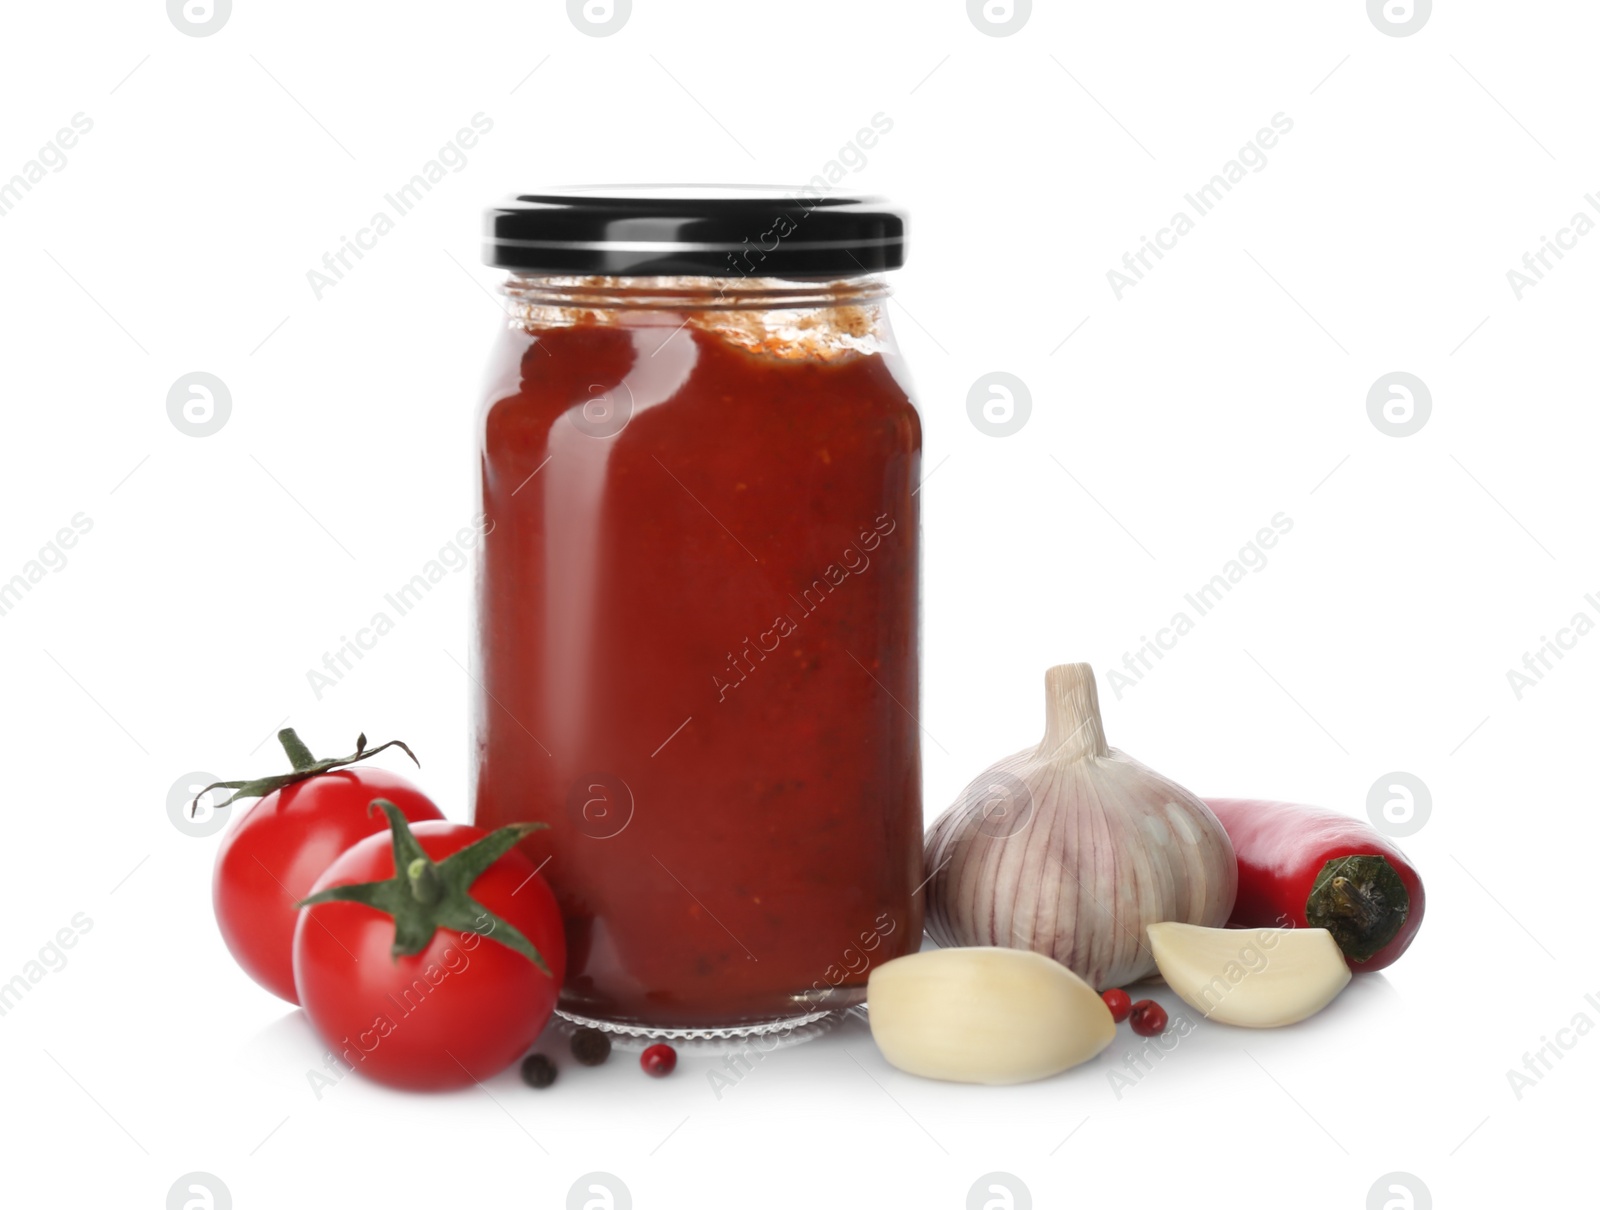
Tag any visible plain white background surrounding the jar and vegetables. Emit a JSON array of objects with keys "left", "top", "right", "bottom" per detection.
[{"left": 0, "top": 0, "right": 1600, "bottom": 1210}]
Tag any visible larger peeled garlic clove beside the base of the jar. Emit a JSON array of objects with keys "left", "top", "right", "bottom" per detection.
[{"left": 867, "top": 946, "right": 1117, "bottom": 1084}]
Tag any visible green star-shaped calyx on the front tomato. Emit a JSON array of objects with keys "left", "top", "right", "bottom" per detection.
[{"left": 299, "top": 799, "right": 555, "bottom": 978}]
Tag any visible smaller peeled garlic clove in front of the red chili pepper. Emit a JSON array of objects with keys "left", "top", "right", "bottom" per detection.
[{"left": 1146, "top": 922, "right": 1350, "bottom": 1029}]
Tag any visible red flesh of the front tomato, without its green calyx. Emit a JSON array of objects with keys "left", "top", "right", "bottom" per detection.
[{"left": 294, "top": 823, "right": 566, "bottom": 1090}]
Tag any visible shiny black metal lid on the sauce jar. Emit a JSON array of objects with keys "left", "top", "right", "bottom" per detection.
[{"left": 483, "top": 186, "right": 906, "bottom": 277}]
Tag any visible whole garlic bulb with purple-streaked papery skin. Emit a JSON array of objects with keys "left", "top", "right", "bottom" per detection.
[{"left": 925, "top": 664, "right": 1238, "bottom": 991}]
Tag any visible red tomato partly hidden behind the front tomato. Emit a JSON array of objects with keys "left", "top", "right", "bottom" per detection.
[{"left": 211, "top": 767, "right": 445, "bottom": 1004}]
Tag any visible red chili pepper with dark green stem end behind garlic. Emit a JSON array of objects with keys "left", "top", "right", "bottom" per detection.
[{"left": 1205, "top": 799, "right": 1422, "bottom": 972}]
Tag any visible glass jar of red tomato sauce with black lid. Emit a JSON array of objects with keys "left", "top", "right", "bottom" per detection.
[{"left": 474, "top": 190, "right": 922, "bottom": 1036}]
